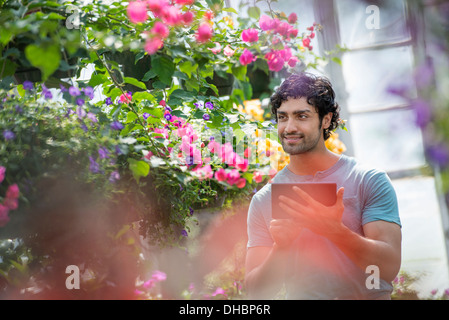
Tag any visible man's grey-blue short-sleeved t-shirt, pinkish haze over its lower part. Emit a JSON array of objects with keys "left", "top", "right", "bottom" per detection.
[{"left": 247, "top": 155, "right": 401, "bottom": 300}]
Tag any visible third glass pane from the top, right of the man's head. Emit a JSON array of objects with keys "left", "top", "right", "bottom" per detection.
[{"left": 348, "top": 110, "right": 426, "bottom": 171}]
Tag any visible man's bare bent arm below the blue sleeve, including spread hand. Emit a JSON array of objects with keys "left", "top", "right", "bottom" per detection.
[{"left": 280, "top": 188, "right": 401, "bottom": 281}]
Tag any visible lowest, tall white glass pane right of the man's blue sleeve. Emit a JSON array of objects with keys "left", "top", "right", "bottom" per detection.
[{"left": 393, "top": 177, "right": 449, "bottom": 296}]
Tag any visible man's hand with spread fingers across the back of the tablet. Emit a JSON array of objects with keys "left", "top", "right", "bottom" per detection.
[{"left": 279, "top": 186, "right": 344, "bottom": 238}]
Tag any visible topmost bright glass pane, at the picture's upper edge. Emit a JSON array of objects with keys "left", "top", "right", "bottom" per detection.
[{"left": 334, "top": 0, "right": 410, "bottom": 49}]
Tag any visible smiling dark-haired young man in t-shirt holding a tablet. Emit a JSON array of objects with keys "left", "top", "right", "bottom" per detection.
[{"left": 245, "top": 73, "right": 401, "bottom": 299}]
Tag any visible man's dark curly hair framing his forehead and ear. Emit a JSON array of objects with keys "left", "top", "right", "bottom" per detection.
[{"left": 270, "top": 72, "right": 340, "bottom": 140}]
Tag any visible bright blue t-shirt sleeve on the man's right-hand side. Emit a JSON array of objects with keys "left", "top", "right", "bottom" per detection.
[{"left": 362, "top": 171, "right": 401, "bottom": 226}]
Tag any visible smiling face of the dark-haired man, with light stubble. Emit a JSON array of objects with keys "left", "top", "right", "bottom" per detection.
[{"left": 277, "top": 98, "right": 322, "bottom": 155}]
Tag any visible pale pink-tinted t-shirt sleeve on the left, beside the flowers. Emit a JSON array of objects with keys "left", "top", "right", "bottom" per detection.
[{"left": 247, "top": 191, "right": 273, "bottom": 248}]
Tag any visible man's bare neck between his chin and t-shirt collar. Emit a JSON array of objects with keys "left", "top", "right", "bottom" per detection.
[{"left": 288, "top": 149, "right": 340, "bottom": 176}]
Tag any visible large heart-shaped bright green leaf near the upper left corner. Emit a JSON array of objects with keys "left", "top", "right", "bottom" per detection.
[{"left": 25, "top": 44, "right": 61, "bottom": 81}]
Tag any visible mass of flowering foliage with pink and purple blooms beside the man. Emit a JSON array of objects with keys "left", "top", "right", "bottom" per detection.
[{"left": 0, "top": 0, "right": 346, "bottom": 298}]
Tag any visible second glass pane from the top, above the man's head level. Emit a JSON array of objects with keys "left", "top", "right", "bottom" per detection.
[{"left": 342, "top": 46, "right": 414, "bottom": 112}]
